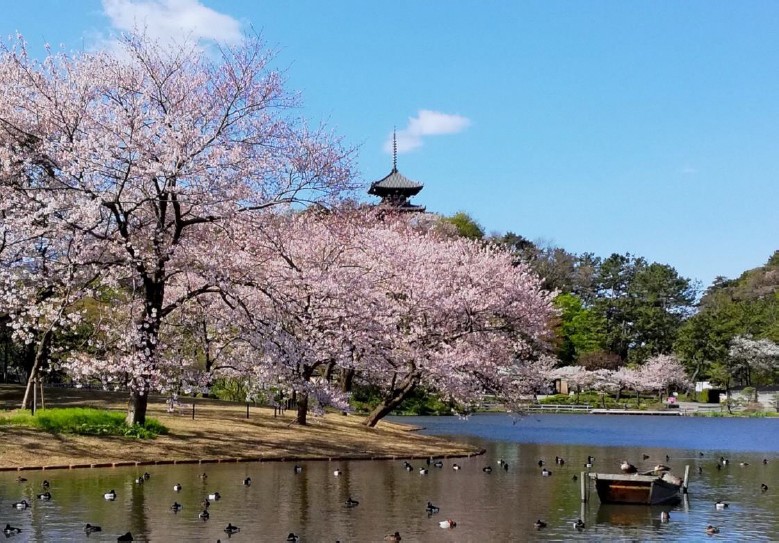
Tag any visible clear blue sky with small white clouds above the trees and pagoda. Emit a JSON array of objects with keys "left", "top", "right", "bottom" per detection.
[{"left": 0, "top": 0, "right": 779, "bottom": 287}]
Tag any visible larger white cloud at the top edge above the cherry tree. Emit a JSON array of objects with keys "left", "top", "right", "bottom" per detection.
[{"left": 103, "top": 0, "right": 243, "bottom": 44}]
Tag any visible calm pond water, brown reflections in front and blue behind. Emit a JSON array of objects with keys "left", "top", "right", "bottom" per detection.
[{"left": 0, "top": 415, "right": 779, "bottom": 543}]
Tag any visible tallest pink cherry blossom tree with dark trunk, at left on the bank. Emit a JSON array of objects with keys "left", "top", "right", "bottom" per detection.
[{"left": 0, "top": 34, "right": 352, "bottom": 423}]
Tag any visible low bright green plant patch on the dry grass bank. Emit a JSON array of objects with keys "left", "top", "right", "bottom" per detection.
[{"left": 0, "top": 407, "right": 168, "bottom": 439}]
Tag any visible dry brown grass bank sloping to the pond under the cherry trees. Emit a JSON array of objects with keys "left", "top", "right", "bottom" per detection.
[{"left": 0, "top": 385, "right": 478, "bottom": 468}]
